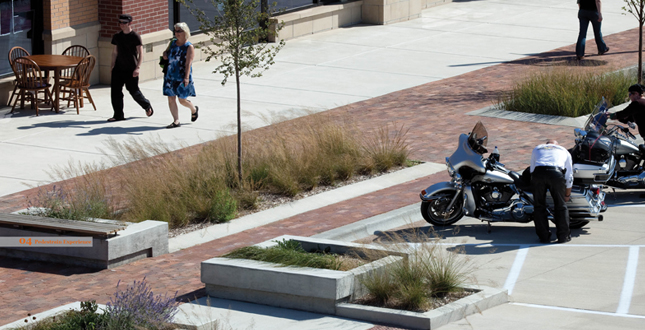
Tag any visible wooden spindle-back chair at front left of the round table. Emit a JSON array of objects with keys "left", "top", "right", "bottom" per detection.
[{"left": 11, "top": 57, "right": 54, "bottom": 116}]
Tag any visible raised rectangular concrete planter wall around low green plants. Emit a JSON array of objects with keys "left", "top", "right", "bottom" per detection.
[{"left": 201, "top": 236, "right": 407, "bottom": 314}]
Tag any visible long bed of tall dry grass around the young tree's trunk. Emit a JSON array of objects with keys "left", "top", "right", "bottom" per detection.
[{"left": 31, "top": 114, "right": 409, "bottom": 228}]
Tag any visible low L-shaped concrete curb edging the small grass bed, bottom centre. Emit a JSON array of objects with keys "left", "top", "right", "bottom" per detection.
[{"left": 336, "top": 285, "right": 508, "bottom": 329}]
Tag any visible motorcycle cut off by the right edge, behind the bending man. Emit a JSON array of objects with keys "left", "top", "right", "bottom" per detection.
[{"left": 571, "top": 99, "right": 645, "bottom": 189}]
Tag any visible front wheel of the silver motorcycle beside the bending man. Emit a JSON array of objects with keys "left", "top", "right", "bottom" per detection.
[{"left": 421, "top": 191, "right": 464, "bottom": 227}]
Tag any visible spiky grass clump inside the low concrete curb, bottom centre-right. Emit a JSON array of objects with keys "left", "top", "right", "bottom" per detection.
[{"left": 357, "top": 229, "right": 474, "bottom": 311}]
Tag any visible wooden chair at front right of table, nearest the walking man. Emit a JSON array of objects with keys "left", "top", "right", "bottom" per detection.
[{"left": 60, "top": 55, "right": 96, "bottom": 114}]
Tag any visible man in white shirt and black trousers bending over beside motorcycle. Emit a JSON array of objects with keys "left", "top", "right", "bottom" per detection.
[{"left": 530, "top": 140, "right": 573, "bottom": 243}]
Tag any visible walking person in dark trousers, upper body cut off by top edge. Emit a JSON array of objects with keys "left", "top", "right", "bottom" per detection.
[{"left": 576, "top": 0, "right": 609, "bottom": 60}]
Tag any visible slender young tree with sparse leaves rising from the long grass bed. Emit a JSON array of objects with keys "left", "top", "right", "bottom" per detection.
[{"left": 178, "top": 0, "right": 284, "bottom": 183}]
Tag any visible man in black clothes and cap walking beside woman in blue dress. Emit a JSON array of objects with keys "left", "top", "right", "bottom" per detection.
[{"left": 108, "top": 14, "right": 154, "bottom": 122}]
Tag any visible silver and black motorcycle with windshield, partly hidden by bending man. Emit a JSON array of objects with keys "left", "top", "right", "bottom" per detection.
[{"left": 420, "top": 121, "right": 606, "bottom": 232}]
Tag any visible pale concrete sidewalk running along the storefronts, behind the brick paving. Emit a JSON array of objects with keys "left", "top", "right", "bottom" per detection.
[{"left": 0, "top": 0, "right": 636, "bottom": 196}]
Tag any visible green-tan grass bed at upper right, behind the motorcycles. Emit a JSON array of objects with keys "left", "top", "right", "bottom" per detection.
[{"left": 498, "top": 67, "right": 637, "bottom": 117}]
